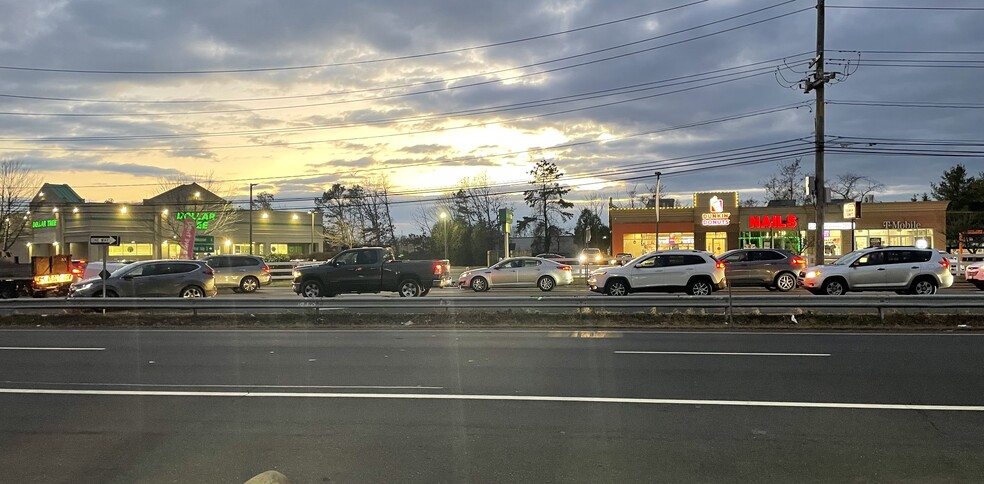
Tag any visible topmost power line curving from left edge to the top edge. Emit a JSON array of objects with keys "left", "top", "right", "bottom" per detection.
[{"left": 0, "top": 0, "right": 708, "bottom": 75}]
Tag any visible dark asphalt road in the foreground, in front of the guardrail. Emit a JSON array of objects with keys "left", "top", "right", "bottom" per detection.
[{"left": 0, "top": 330, "right": 984, "bottom": 482}]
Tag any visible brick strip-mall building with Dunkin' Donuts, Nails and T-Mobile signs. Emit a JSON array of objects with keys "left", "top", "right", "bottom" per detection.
[{"left": 609, "top": 192, "right": 949, "bottom": 257}]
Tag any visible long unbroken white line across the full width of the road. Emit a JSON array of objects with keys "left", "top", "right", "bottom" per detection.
[{"left": 0, "top": 388, "right": 984, "bottom": 412}]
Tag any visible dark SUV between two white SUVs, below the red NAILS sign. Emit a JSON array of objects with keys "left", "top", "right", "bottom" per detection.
[{"left": 718, "top": 249, "right": 806, "bottom": 292}]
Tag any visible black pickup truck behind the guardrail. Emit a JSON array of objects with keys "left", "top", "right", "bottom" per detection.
[{"left": 291, "top": 247, "right": 452, "bottom": 297}]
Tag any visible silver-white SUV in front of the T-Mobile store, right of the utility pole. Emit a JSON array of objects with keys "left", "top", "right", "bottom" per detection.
[{"left": 799, "top": 247, "right": 953, "bottom": 296}]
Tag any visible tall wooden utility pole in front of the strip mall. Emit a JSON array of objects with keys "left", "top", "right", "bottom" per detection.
[{"left": 804, "top": 0, "right": 836, "bottom": 265}]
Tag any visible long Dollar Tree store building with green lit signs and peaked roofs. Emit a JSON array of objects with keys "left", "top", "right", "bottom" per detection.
[{"left": 22, "top": 183, "right": 323, "bottom": 260}]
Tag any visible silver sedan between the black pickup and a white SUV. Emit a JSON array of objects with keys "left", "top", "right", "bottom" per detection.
[{"left": 458, "top": 257, "right": 574, "bottom": 292}]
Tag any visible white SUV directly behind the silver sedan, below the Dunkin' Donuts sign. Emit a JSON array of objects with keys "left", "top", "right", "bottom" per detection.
[{"left": 588, "top": 250, "right": 727, "bottom": 296}]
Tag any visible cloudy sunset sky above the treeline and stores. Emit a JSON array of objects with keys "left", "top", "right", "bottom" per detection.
[{"left": 0, "top": 0, "right": 984, "bottom": 232}]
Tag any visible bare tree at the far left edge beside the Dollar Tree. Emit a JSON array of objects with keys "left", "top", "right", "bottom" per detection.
[{"left": 0, "top": 159, "right": 41, "bottom": 252}]
